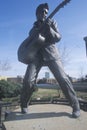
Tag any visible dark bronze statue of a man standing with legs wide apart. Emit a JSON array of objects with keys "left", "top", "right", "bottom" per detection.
[{"left": 21, "top": 3, "right": 80, "bottom": 118}]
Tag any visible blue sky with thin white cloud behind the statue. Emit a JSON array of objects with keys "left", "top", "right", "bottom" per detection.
[{"left": 0, "top": 0, "right": 87, "bottom": 78}]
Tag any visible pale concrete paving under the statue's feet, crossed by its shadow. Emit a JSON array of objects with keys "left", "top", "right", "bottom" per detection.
[{"left": 4, "top": 104, "right": 87, "bottom": 130}]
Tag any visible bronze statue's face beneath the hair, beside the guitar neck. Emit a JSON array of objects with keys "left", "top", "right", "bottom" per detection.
[{"left": 37, "top": 8, "right": 48, "bottom": 21}]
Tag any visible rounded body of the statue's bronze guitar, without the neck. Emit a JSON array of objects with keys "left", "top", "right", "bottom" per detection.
[{"left": 18, "top": 34, "right": 45, "bottom": 64}]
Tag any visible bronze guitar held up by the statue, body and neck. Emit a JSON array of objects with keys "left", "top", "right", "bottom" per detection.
[{"left": 18, "top": 0, "right": 71, "bottom": 64}]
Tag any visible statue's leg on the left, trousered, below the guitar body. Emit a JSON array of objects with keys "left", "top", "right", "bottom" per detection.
[{"left": 20, "top": 62, "right": 41, "bottom": 113}]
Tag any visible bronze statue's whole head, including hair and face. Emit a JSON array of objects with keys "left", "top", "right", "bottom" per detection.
[{"left": 36, "top": 3, "right": 49, "bottom": 21}]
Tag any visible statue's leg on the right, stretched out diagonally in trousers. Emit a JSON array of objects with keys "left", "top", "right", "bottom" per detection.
[{"left": 48, "top": 61, "right": 80, "bottom": 117}]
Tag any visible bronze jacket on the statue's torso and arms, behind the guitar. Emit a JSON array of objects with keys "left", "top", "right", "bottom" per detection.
[{"left": 29, "top": 18, "right": 61, "bottom": 61}]
